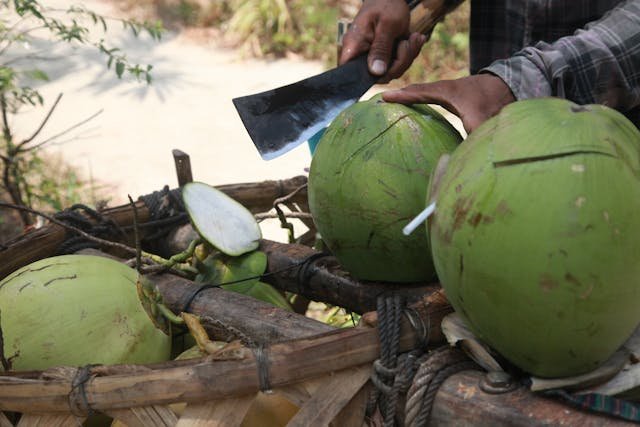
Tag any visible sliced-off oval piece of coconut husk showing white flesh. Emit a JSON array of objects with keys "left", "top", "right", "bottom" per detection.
[{"left": 182, "top": 182, "right": 262, "bottom": 256}]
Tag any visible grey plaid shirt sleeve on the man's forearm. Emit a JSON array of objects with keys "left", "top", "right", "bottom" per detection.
[{"left": 480, "top": 0, "right": 640, "bottom": 111}]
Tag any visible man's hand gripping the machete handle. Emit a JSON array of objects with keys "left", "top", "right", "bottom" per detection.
[{"left": 339, "top": 0, "right": 427, "bottom": 83}]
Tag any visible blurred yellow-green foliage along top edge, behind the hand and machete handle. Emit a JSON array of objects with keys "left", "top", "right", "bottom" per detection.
[{"left": 118, "top": 0, "right": 469, "bottom": 85}]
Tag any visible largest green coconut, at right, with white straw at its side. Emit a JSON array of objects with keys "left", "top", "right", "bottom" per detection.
[{"left": 430, "top": 98, "right": 640, "bottom": 377}]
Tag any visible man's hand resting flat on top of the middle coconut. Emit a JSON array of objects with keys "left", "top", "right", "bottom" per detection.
[{"left": 382, "top": 74, "right": 515, "bottom": 133}]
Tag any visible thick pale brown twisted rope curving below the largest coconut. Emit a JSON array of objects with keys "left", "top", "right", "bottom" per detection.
[{"left": 404, "top": 346, "right": 477, "bottom": 427}]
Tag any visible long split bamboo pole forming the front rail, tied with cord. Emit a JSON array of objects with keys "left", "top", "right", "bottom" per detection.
[{"left": 0, "top": 328, "right": 414, "bottom": 413}]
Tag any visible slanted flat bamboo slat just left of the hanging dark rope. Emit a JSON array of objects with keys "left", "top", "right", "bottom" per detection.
[{"left": 287, "top": 365, "right": 371, "bottom": 427}]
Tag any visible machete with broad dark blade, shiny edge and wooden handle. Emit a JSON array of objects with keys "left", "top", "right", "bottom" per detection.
[{"left": 233, "top": 0, "right": 449, "bottom": 160}]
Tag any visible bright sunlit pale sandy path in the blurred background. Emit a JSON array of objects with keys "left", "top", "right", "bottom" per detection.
[{"left": 18, "top": 0, "right": 322, "bottom": 204}]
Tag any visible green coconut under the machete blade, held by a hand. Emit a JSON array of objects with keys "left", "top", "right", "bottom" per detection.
[{"left": 308, "top": 97, "right": 461, "bottom": 282}]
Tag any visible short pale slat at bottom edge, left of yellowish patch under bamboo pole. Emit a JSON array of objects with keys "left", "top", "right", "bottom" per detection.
[{"left": 176, "top": 394, "right": 255, "bottom": 427}]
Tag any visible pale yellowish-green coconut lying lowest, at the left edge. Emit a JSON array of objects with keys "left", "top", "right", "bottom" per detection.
[{"left": 0, "top": 255, "right": 171, "bottom": 370}]
